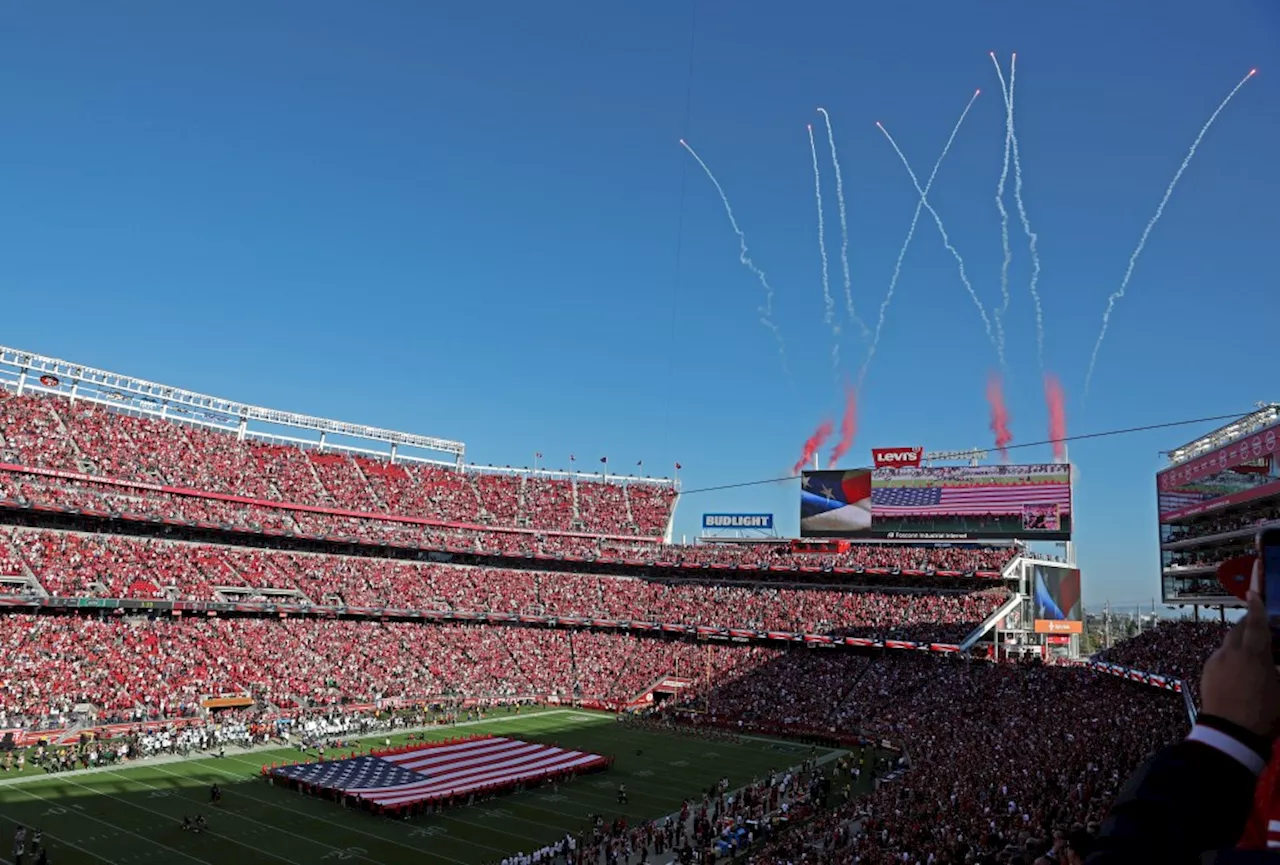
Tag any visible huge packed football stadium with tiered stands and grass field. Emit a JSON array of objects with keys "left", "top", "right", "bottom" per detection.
[{"left": 0, "top": 348, "right": 1249, "bottom": 862}]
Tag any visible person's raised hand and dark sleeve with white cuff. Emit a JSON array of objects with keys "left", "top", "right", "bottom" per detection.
[{"left": 1084, "top": 564, "right": 1280, "bottom": 865}]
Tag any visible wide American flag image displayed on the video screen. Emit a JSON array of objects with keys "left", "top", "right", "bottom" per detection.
[{"left": 872, "top": 482, "right": 1071, "bottom": 517}]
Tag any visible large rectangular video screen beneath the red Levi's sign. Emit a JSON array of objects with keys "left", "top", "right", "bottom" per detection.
[{"left": 800, "top": 463, "right": 1071, "bottom": 541}]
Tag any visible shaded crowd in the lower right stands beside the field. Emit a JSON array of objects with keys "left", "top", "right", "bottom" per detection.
[{"left": 673, "top": 653, "right": 1187, "bottom": 865}]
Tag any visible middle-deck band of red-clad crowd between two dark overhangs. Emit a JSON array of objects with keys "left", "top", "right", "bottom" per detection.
[{"left": 0, "top": 528, "right": 1007, "bottom": 642}]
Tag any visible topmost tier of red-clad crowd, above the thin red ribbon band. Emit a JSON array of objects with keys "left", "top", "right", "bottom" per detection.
[{"left": 0, "top": 392, "right": 676, "bottom": 537}]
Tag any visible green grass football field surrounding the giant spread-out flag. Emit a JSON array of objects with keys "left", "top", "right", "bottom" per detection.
[{"left": 0, "top": 710, "right": 849, "bottom": 865}]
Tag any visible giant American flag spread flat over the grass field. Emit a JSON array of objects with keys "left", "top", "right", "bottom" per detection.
[{"left": 271, "top": 736, "right": 608, "bottom": 806}]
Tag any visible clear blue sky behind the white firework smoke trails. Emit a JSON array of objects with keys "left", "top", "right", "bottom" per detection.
[{"left": 0, "top": 0, "right": 1280, "bottom": 605}]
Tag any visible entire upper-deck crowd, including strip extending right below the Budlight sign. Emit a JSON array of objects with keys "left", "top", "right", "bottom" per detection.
[{"left": 0, "top": 393, "right": 1015, "bottom": 588}]
